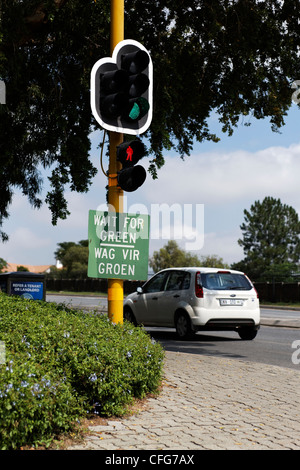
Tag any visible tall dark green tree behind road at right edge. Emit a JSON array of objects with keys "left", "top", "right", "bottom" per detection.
[{"left": 233, "top": 197, "right": 300, "bottom": 280}]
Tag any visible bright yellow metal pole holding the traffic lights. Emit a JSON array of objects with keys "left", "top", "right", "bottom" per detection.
[{"left": 107, "top": 0, "right": 124, "bottom": 323}]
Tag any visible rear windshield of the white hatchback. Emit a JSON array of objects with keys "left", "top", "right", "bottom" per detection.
[{"left": 201, "top": 273, "right": 252, "bottom": 290}]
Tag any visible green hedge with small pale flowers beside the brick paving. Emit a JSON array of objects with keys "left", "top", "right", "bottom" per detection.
[{"left": 0, "top": 293, "right": 164, "bottom": 450}]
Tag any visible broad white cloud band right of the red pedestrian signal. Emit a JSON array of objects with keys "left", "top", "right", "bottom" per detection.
[{"left": 145, "top": 144, "right": 300, "bottom": 205}]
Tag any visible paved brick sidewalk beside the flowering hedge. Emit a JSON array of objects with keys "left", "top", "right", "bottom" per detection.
[{"left": 69, "top": 352, "right": 300, "bottom": 450}]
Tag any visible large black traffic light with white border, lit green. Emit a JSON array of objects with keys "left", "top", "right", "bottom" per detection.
[{"left": 91, "top": 39, "right": 153, "bottom": 135}]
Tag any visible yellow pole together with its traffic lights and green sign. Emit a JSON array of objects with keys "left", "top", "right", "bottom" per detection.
[{"left": 88, "top": 0, "right": 153, "bottom": 324}]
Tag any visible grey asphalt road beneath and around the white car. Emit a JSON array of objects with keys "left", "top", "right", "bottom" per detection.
[{"left": 47, "top": 294, "right": 300, "bottom": 371}]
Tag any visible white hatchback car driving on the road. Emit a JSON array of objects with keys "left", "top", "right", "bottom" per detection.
[{"left": 124, "top": 268, "right": 260, "bottom": 340}]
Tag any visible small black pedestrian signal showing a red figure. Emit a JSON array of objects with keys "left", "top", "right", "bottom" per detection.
[{"left": 117, "top": 139, "right": 146, "bottom": 192}]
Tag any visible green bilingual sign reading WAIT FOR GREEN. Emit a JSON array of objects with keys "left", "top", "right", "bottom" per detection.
[{"left": 88, "top": 210, "right": 150, "bottom": 281}]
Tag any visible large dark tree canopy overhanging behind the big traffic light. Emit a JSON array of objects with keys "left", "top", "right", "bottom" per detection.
[{"left": 0, "top": 0, "right": 300, "bottom": 240}]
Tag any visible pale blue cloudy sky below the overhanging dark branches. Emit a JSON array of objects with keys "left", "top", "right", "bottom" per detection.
[{"left": 0, "top": 104, "right": 300, "bottom": 265}]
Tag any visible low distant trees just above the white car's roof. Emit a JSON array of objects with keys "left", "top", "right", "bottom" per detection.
[{"left": 149, "top": 240, "right": 228, "bottom": 272}]
